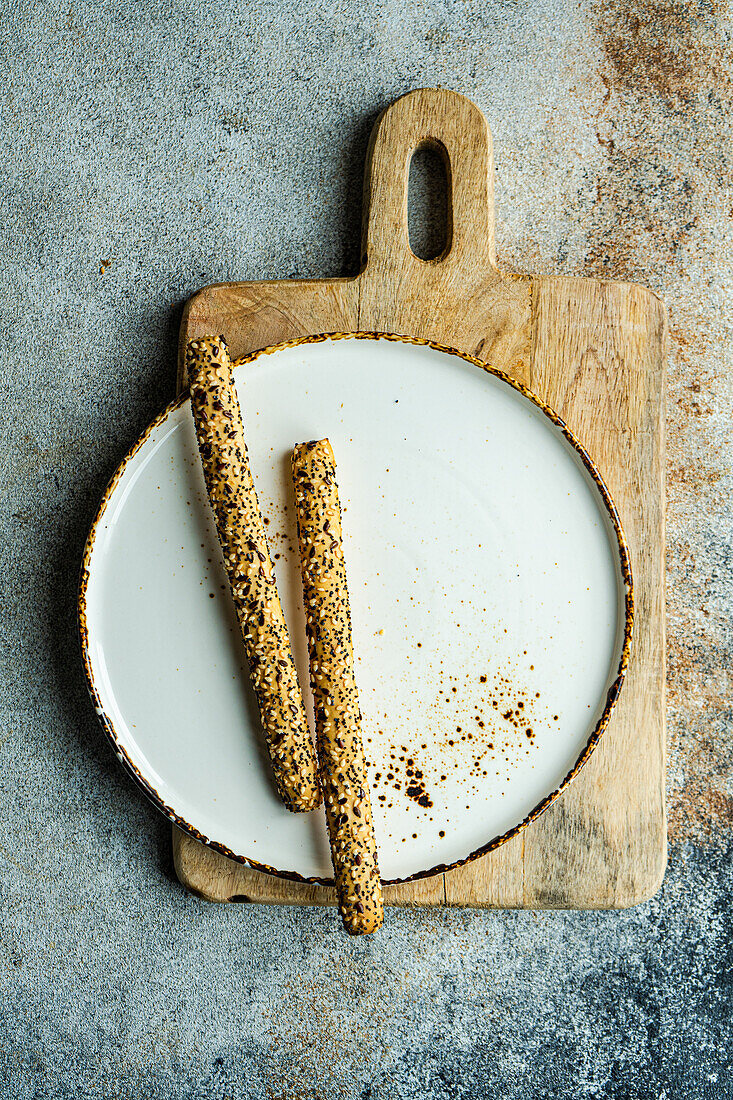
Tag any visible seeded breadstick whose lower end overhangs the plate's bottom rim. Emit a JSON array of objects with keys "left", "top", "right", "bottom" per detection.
[{"left": 293, "top": 439, "right": 384, "bottom": 936}]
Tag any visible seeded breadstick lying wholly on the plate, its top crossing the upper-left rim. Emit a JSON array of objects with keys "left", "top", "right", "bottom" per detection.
[{"left": 186, "top": 337, "right": 320, "bottom": 812}]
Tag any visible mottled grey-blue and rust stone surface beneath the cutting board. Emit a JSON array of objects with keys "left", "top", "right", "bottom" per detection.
[{"left": 0, "top": 0, "right": 733, "bottom": 1100}]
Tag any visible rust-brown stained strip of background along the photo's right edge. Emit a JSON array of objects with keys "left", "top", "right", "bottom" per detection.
[{"left": 571, "top": 0, "right": 733, "bottom": 843}]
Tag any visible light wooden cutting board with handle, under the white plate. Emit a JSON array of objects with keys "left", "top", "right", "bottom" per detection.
[{"left": 173, "top": 88, "right": 667, "bottom": 909}]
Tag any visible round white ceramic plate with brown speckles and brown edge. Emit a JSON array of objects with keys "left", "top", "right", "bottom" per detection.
[{"left": 80, "top": 334, "right": 633, "bottom": 881}]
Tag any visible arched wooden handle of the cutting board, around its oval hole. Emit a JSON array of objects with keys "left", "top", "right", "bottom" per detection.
[{"left": 362, "top": 88, "right": 495, "bottom": 282}]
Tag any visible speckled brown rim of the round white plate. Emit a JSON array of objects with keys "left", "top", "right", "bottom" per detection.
[{"left": 77, "top": 330, "right": 635, "bottom": 887}]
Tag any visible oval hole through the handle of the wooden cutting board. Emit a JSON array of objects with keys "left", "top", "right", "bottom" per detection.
[{"left": 407, "top": 141, "right": 451, "bottom": 262}]
